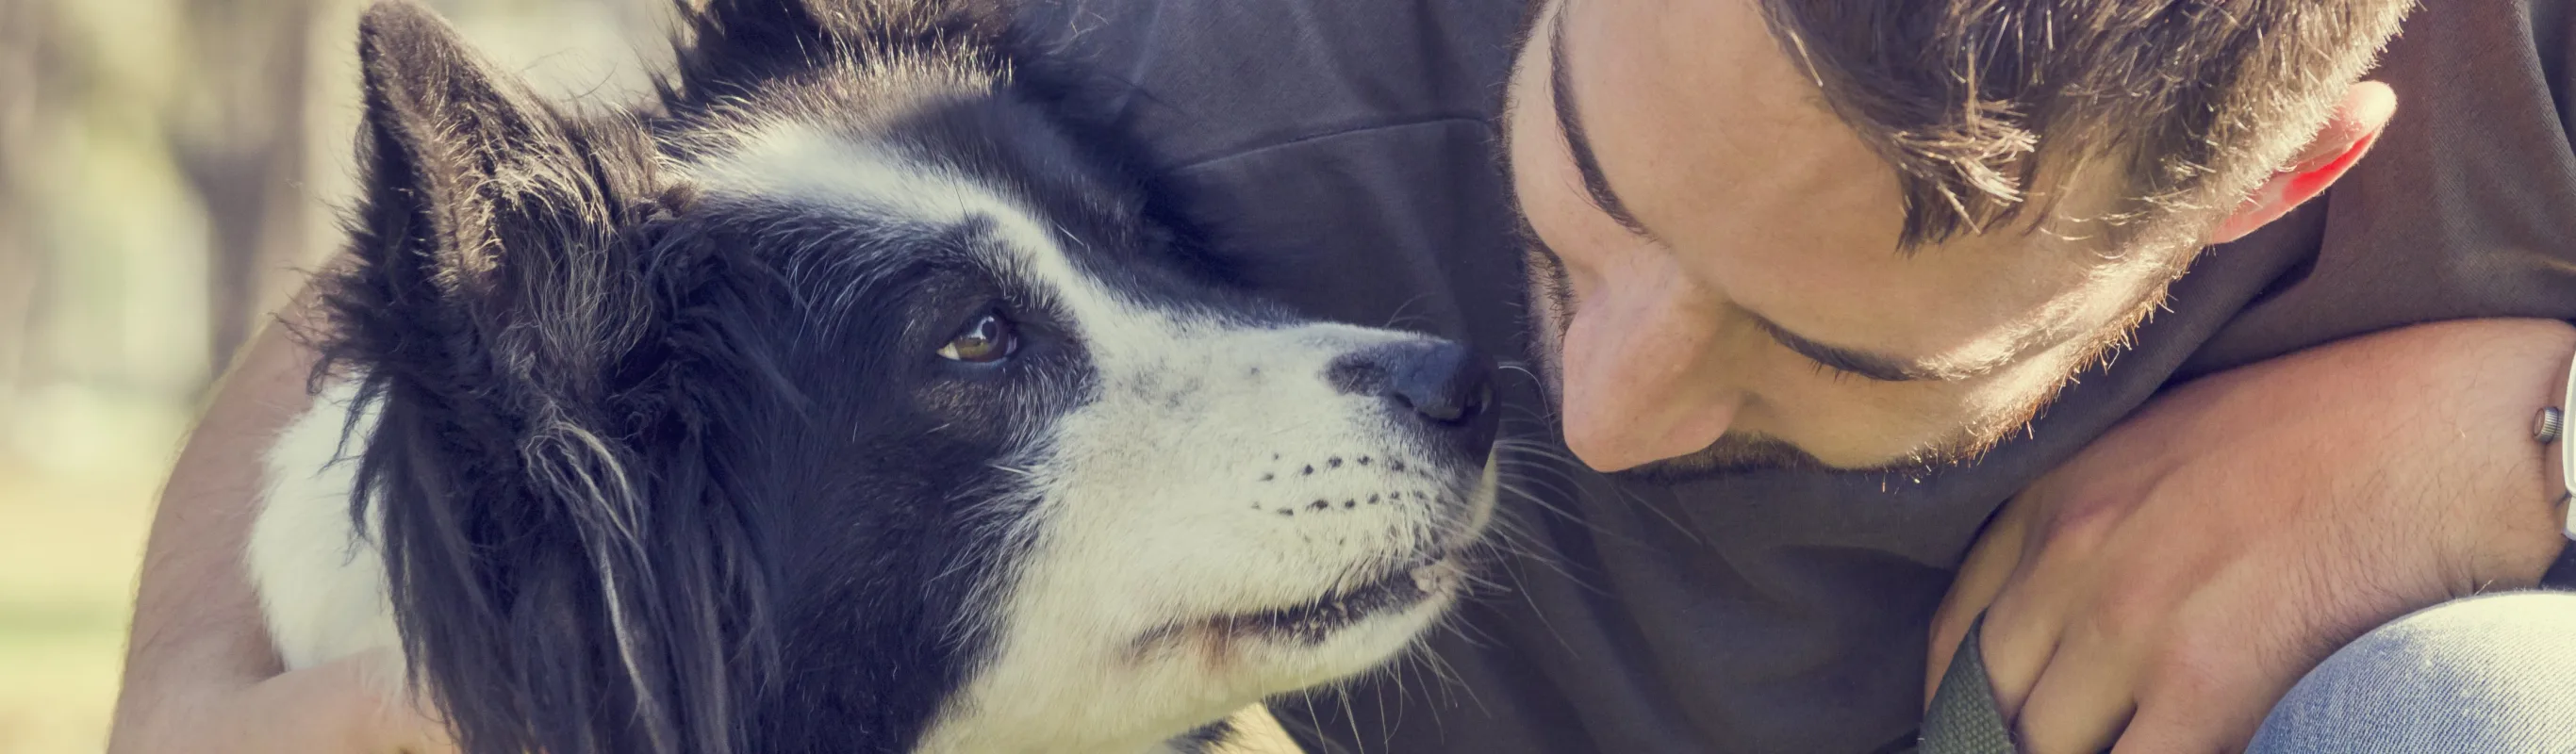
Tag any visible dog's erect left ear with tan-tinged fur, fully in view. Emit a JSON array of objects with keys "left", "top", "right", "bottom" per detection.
[{"left": 358, "top": 0, "right": 649, "bottom": 396}]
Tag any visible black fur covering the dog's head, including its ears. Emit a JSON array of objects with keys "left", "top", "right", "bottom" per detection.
[{"left": 314, "top": 0, "right": 1230, "bottom": 754}]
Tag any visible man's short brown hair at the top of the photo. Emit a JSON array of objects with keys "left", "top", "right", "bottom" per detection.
[{"left": 1762, "top": 0, "right": 2414, "bottom": 247}]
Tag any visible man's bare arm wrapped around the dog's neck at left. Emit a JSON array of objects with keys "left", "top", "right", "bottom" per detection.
[{"left": 108, "top": 290, "right": 451, "bottom": 754}]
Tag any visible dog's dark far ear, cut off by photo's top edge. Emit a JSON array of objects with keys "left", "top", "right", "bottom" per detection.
[{"left": 678, "top": 0, "right": 1007, "bottom": 100}]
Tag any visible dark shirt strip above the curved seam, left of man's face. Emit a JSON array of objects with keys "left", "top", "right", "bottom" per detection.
[{"left": 1017, "top": 0, "right": 1517, "bottom": 170}]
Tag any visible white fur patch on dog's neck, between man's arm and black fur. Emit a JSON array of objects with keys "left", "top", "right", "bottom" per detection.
[{"left": 247, "top": 384, "right": 402, "bottom": 690}]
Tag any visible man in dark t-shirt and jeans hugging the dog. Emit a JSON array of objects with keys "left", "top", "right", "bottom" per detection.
[{"left": 106, "top": 0, "right": 2576, "bottom": 751}]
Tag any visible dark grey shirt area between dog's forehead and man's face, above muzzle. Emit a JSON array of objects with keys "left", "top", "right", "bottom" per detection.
[{"left": 1017, "top": 0, "right": 1520, "bottom": 342}]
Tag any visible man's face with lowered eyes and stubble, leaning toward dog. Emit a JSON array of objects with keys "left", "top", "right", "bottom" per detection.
[{"left": 1504, "top": 0, "right": 2177, "bottom": 476}]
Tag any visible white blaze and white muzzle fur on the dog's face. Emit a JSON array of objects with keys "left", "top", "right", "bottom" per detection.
[{"left": 698, "top": 129, "right": 1484, "bottom": 754}]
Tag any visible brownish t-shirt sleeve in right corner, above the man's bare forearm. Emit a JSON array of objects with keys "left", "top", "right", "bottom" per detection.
[{"left": 2177, "top": 0, "right": 2576, "bottom": 378}]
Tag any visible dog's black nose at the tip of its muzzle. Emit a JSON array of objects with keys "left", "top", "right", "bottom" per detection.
[{"left": 1331, "top": 339, "right": 1496, "bottom": 461}]
